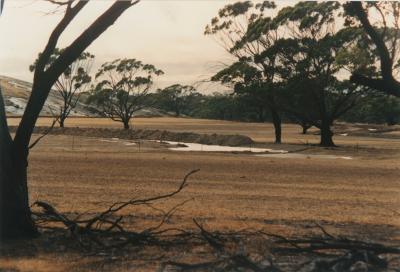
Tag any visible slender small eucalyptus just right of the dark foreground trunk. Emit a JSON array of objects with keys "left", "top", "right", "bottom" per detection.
[{"left": 29, "top": 48, "right": 94, "bottom": 127}]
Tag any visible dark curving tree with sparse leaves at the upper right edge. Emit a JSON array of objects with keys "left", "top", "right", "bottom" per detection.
[{"left": 345, "top": 1, "right": 400, "bottom": 97}]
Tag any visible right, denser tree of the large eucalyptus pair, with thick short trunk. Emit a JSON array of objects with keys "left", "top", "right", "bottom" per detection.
[{"left": 274, "top": 2, "right": 361, "bottom": 146}]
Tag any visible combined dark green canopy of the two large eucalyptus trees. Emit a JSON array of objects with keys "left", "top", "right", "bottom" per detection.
[{"left": 206, "top": 1, "right": 382, "bottom": 144}]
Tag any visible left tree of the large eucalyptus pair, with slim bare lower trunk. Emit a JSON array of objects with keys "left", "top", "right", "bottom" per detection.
[{"left": 205, "top": 1, "right": 282, "bottom": 143}]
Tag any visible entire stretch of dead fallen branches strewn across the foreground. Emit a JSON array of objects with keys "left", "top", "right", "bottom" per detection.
[{"left": 28, "top": 170, "right": 400, "bottom": 272}]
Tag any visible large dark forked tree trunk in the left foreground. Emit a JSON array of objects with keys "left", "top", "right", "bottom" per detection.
[{"left": 0, "top": 0, "right": 139, "bottom": 239}]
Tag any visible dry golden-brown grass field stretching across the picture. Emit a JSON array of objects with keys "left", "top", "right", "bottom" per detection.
[{"left": 0, "top": 118, "right": 400, "bottom": 271}]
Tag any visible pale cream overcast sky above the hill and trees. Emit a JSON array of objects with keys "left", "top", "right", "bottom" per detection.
[{"left": 0, "top": 0, "right": 289, "bottom": 92}]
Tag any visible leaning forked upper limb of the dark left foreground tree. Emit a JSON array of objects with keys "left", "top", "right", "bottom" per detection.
[{"left": 14, "top": 0, "right": 139, "bottom": 153}]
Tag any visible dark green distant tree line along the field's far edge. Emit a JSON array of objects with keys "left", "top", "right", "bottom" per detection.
[{"left": 147, "top": 90, "right": 400, "bottom": 128}]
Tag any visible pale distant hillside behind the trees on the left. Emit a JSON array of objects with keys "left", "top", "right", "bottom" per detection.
[{"left": 0, "top": 75, "right": 169, "bottom": 117}]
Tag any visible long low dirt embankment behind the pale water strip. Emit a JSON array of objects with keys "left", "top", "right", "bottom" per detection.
[{"left": 10, "top": 127, "right": 254, "bottom": 146}]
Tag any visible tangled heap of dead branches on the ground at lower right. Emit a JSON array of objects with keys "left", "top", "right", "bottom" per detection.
[{"left": 163, "top": 220, "right": 400, "bottom": 272}]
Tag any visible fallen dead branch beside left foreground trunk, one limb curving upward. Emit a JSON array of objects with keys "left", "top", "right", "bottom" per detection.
[{"left": 33, "top": 169, "right": 199, "bottom": 250}]
